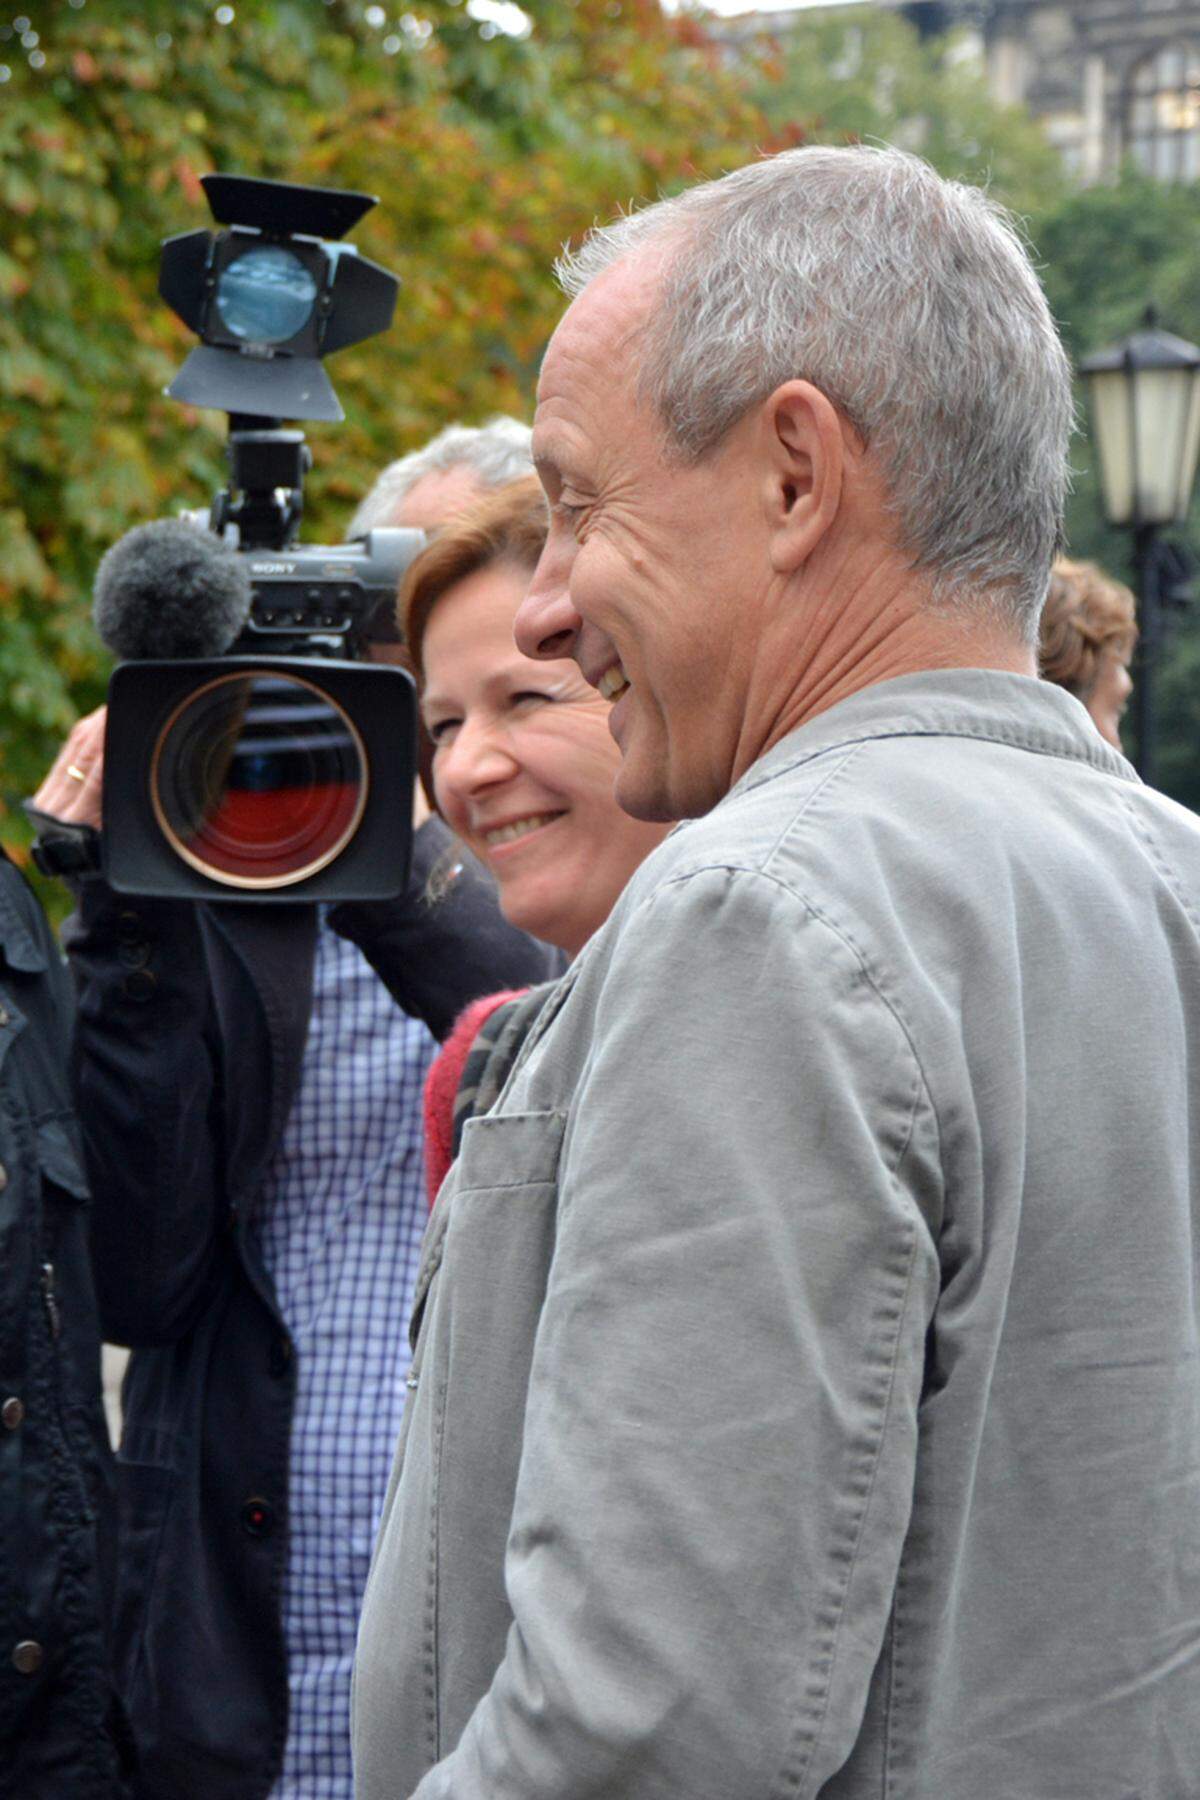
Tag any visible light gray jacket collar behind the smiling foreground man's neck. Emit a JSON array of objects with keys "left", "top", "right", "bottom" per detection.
[{"left": 730, "top": 670, "right": 1139, "bottom": 797}]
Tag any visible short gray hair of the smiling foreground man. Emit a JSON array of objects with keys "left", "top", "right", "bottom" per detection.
[{"left": 556, "top": 146, "right": 1074, "bottom": 643}]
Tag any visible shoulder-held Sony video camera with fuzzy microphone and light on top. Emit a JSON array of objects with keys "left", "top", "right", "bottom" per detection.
[{"left": 95, "top": 175, "right": 425, "bottom": 902}]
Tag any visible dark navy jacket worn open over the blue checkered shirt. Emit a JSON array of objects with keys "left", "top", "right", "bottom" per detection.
[{"left": 67, "top": 821, "right": 556, "bottom": 1800}]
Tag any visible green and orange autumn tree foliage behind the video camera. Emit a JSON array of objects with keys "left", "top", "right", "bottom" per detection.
[{"left": 0, "top": 0, "right": 763, "bottom": 878}]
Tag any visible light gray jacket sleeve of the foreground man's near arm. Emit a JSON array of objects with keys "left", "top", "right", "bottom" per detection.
[{"left": 416, "top": 869, "right": 941, "bottom": 1800}]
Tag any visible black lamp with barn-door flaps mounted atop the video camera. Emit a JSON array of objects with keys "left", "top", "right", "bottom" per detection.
[{"left": 158, "top": 175, "right": 399, "bottom": 419}]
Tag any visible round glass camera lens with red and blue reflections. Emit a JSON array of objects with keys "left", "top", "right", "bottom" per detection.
[{"left": 149, "top": 671, "right": 367, "bottom": 889}]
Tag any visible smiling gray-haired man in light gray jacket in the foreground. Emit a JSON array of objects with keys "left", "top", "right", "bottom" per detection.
[{"left": 354, "top": 149, "right": 1200, "bottom": 1800}]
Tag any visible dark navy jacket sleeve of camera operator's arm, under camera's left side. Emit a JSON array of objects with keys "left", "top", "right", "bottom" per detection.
[{"left": 63, "top": 877, "right": 227, "bottom": 1345}]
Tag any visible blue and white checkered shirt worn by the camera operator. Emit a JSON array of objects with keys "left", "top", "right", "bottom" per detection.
[{"left": 257, "top": 922, "right": 437, "bottom": 1800}]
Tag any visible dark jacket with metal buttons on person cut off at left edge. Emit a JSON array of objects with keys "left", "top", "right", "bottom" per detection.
[{"left": 0, "top": 851, "right": 124, "bottom": 1800}]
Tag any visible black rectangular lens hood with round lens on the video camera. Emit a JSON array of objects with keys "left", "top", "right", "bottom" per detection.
[{"left": 103, "top": 655, "right": 416, "bottom": 902}]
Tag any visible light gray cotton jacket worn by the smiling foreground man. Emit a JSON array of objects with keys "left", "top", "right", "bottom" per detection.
[{"left": 354, "top": 670, "right": 1200, "bottom": 1800}]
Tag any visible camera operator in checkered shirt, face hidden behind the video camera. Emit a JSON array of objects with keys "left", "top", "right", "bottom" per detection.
[{"left": 38, "top": 419, "right": 558, "bottom": 1800}]
